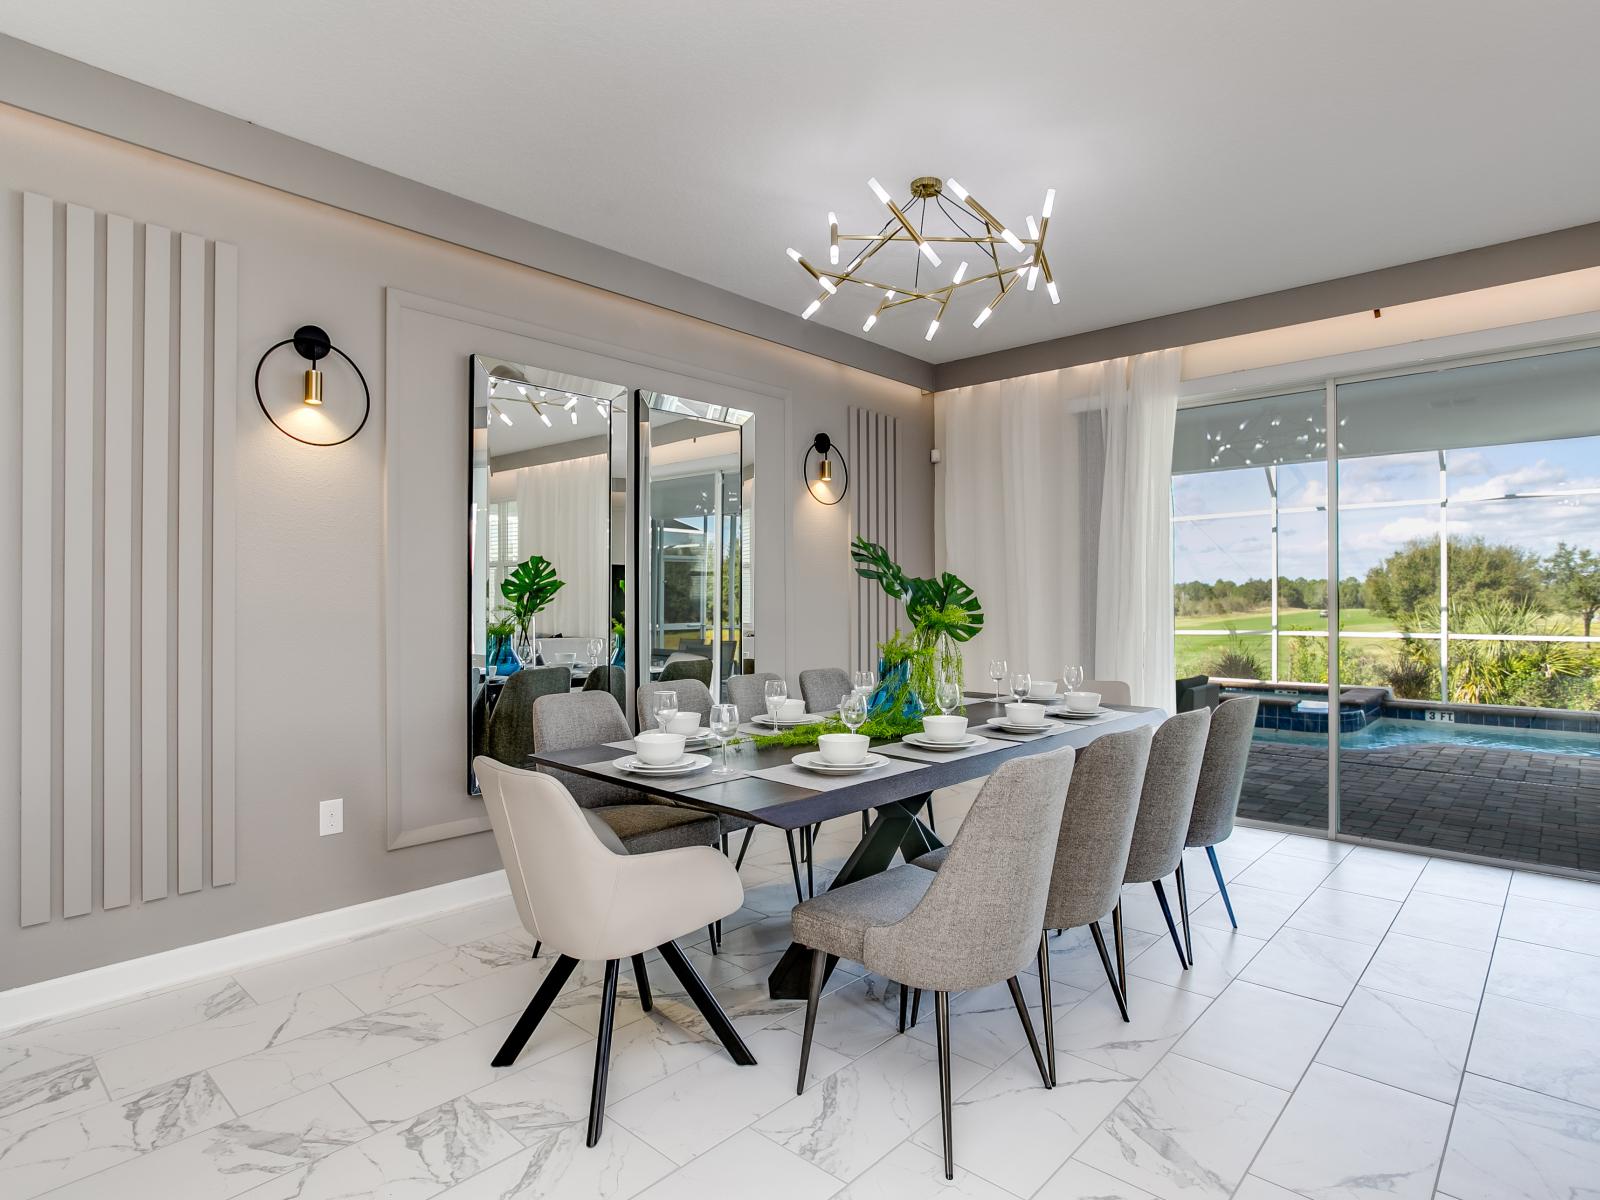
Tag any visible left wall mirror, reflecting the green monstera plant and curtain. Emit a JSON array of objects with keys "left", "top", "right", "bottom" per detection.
[{"left": 469, "top": 355, "right": 627, "bottom": 790}]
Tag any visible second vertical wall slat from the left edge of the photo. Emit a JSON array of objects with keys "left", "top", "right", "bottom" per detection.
[{"left": 61, "top": 205, "right": 99, "bottom": 917}]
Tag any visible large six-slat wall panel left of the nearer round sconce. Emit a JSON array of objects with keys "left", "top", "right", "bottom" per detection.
[{"left": 18, "top": 192, "right": 238, "bottom": 925}]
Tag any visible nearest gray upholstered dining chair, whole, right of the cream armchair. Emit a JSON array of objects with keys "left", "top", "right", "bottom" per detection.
[{"left": 794, "top": 747, "right": 1074, "bottom": 1179}]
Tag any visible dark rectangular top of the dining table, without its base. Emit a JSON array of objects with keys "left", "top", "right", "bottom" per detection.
[{"left": 530, "top": 702, "right": 1166, "bottom": 829}]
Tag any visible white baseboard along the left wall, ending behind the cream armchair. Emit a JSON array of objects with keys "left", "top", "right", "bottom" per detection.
[{"left": 0, "top": 870, "right": 509, "bottom": 1030}]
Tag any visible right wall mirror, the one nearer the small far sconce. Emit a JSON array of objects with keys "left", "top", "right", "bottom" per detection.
[{"left": 642, "top": 392, "right": 755, "bottom": 699}]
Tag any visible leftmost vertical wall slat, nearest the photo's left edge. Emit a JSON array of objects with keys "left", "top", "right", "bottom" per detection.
[{"left": 18, "top": 192, "right": 56, "bottom": 925}]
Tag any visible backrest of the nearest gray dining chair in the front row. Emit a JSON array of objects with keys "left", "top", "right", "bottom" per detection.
[{"left": 866, "top": 747, "right": 1074, "bottom": 992}]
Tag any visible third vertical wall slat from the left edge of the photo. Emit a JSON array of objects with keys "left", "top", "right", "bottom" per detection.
[{"left": 101, "top": 216, "right": 134, "bottom": 909}]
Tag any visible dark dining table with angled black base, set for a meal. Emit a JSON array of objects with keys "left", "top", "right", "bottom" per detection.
[{"left": 528, "top": 698, "right": 1166, "bottom": 1000}]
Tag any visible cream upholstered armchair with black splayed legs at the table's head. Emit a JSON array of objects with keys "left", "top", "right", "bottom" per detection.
[{"left": 474, "top": 757, "right": 755, "bottom": 1146}]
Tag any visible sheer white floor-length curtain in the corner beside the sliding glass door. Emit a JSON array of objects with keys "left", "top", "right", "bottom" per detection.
[{"left": 934, "top": 350, "right": 1181, "bottom": 709}]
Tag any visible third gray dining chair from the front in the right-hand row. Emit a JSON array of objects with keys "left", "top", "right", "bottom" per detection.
[{"left": 1112, "top": 709, "right": 1211, "bottom": 979}]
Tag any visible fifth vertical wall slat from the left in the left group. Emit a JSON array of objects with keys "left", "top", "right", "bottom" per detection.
[{"left": 178, "top": 234, "right": 205, "bottom": 893}]
